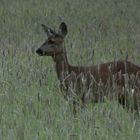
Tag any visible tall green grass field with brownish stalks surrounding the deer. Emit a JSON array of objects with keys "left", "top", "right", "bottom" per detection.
[{"left": 0, "top": 0, "right": 140, "bottom": 140}]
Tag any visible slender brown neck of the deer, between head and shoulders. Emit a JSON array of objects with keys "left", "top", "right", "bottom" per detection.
[{"left": 53, "top": 52, "right": 69, "bottom": 81}]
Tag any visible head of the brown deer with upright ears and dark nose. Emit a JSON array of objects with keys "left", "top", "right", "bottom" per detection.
[{"left": 36, "top": 22, "right": 67, "bottom": 56}]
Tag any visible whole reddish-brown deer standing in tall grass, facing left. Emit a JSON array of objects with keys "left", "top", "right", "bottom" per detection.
[{"left": 36, "top": 22, "right": 140, "bottom": 112}]
